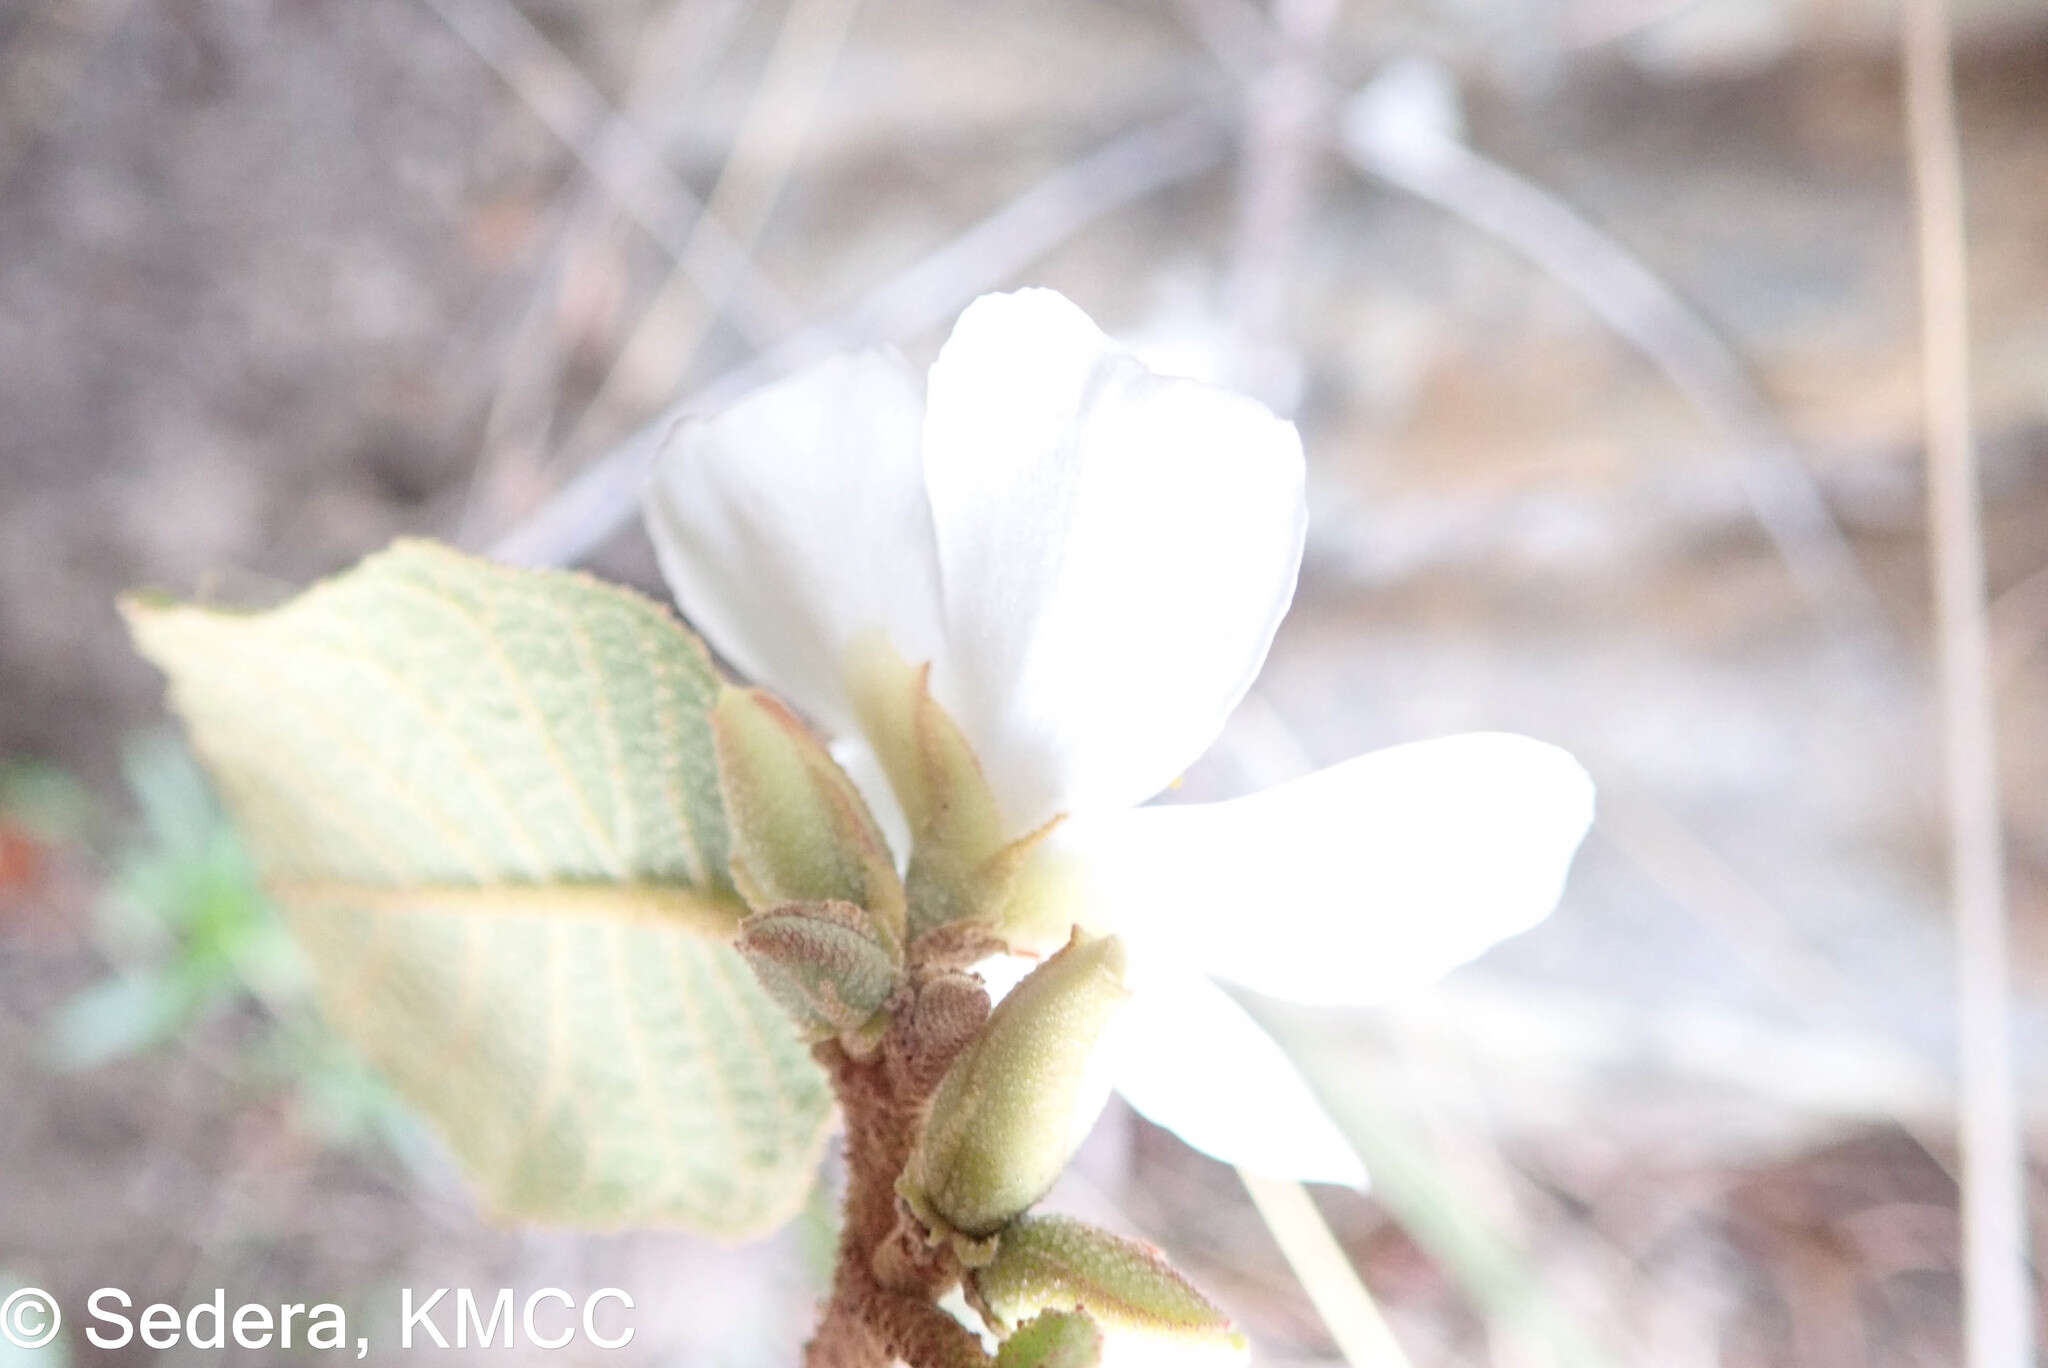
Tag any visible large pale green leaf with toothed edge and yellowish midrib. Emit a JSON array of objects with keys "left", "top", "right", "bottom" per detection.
[{"left": 125, "top": 543, "right": 829, "bottom": 1237}]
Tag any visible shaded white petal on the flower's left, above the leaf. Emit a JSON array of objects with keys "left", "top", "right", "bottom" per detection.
[{"left": 643, "top": 350, "right": 938, "bottom": 733}]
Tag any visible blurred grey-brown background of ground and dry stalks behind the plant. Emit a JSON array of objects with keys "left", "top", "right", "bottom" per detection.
[{"left": 0, "top": 0, "right": 2048, "bottom": 1368}]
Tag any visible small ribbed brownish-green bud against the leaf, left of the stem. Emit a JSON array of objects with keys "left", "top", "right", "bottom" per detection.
[{"left": 739, "top": 903, "right": 901, "bottom": 1040}]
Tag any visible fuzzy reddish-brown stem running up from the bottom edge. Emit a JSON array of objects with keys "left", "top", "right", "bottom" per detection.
[{"left": 803, "top": 967, "right": 989, "bottom": 1368}]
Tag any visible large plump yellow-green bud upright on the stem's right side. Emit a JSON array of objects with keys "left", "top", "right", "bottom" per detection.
[{"left": 897, "top": 932, "right": 1130, "bottom": 1262}]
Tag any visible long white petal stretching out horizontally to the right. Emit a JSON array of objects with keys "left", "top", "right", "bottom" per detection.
[{"left": 1049, "top": 733, "right": 1593, "bottom": 1003}]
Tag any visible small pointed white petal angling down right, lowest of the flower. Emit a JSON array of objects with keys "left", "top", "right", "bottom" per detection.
[{"left": 1104, "top": 967, "right": 1366, "bottom": 1188}]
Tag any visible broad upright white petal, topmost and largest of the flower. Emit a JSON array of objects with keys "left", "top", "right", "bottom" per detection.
[{"left": 924, "top": 291, "right": 1307, "bottom": 827}]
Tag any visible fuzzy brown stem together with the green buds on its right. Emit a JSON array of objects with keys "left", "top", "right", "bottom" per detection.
[{"left": 782, "top": 932, "right": 1245, "bottom": 1368}]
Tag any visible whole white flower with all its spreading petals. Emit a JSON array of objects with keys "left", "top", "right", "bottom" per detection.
[{"left": 645, "top": 291, "right": 1591, "bottom": 1186}]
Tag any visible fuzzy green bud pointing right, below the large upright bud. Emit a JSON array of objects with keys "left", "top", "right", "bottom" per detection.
[{"left": 969, "top": 1216, "right": 1249, "bottom": 1364}]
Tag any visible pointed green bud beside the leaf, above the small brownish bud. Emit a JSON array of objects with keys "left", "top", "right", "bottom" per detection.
[{"left": 711, "top": 688, "right": 903, "bottom": 960}]
